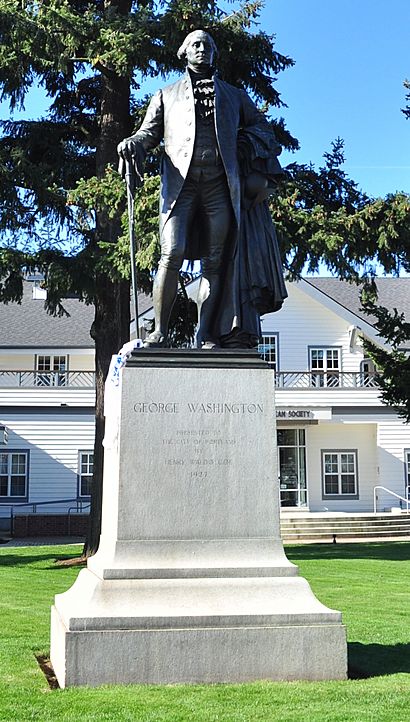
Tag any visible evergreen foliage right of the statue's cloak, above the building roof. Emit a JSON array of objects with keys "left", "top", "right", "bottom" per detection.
[{"left": 271, "top": 138, "right": 410, "bottom": 283}]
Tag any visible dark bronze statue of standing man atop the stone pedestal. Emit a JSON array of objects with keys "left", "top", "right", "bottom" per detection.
[{"left": 118, "top": 30, "right": 287, "bottom": 348}]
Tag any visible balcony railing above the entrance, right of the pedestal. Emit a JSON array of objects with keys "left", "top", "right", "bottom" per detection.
[{"left": 275, "top": 371, "right": 379, "bottom": 389}]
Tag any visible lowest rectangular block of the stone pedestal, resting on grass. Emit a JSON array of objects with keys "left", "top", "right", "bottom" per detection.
[{"left": 51, "top": 608, "right": 347, "bottom": 687}]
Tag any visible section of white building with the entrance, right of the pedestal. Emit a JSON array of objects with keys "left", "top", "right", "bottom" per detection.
[{"left": 262, "top": 278, "right": 410, "bottom": 513}]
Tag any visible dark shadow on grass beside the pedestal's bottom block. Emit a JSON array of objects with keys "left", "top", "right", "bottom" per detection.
[{"left": 348, "top": 642, "right": 410, "bottom": 679}]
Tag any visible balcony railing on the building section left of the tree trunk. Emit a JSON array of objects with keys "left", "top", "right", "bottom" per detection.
[{"left": 0, "top": 370, "right": 95, "bottom": 389}]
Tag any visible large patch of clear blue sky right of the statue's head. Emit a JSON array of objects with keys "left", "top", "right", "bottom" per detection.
[{"left": 260, "top": 0, "right": 410, "bottom": 196}]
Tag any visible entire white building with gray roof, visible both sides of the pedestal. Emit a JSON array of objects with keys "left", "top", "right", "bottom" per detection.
[{"left": 0, "top": 278, "right": 410, "bottom": 519}]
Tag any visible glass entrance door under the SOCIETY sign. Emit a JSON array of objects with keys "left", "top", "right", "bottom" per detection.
[{"left": 277, "top": 428, "right": 307, "bottom": 507}]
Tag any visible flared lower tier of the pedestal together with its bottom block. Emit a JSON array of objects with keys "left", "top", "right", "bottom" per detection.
[{"left": 51, "top": 569, "right": 346, "bottom": 687}]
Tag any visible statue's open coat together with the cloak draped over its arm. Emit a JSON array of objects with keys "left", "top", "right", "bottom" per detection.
[{"left": 132, "top": 72, "right": 287, "bottom": 347}]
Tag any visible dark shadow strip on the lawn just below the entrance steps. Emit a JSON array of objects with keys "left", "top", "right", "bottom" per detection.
[{"left": 285, "top": 541, "right": 410, "bottom": 562}]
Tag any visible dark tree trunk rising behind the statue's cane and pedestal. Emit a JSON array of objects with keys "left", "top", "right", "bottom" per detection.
[{"left": 83, "top": 5, "right": 131, "bottom": 556}]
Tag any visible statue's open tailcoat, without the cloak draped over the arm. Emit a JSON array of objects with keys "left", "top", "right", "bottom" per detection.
[{"left": 132, "top": 71, "right": 281, "bottom": 235}]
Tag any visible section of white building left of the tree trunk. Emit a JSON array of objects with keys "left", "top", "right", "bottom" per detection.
[{"left": 0, "top": 280, "right": 95, "bottom": 526}]
